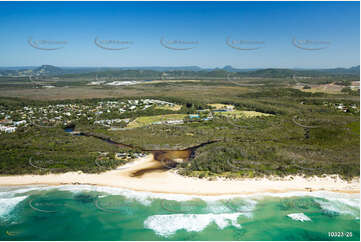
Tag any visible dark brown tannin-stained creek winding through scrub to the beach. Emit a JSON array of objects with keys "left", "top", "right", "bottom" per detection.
[{"left": 64, "top": 126, "right": 220, "bottom": 177}]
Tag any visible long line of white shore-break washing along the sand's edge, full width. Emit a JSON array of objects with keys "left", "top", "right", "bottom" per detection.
[{"left": 0, "top": 185, "right": 360, "bottom": 216}]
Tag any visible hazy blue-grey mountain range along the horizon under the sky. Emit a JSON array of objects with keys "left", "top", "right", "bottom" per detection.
[{"left": 0, "top": 65, "right": 360, "bottom": 78}]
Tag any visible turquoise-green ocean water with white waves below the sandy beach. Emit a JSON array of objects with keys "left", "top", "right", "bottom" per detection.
[{"left": 0, "top": 185, "right": 360, "bottom": 241}]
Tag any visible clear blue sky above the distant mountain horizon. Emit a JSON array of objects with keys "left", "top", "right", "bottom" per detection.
[{"left": 0, "top": 2, "right": 360, "bottom": 68}]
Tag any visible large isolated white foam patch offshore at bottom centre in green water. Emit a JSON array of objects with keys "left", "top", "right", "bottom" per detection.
[{"left": 144, "top": 213, "right": 241, "bottom": 237}]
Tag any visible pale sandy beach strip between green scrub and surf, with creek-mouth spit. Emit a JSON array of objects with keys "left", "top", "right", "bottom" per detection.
[{"left": 0, "top": 155, "right": 360, "bottom": 196}]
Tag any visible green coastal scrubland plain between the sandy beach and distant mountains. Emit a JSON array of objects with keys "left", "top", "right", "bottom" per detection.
[{"left": 0, "top": 72, "right": 360, "bottom": 179}]
